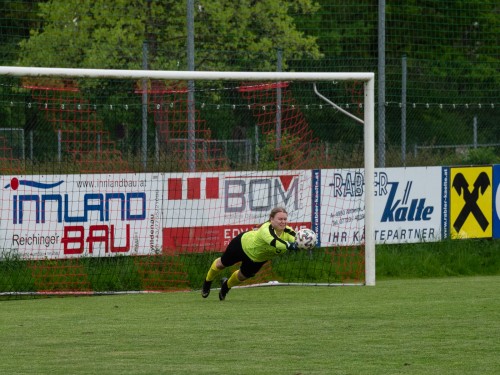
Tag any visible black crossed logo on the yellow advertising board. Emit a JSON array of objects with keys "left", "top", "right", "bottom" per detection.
[{"left": 453, "top": 172, "right": 490, "bottom": 232}]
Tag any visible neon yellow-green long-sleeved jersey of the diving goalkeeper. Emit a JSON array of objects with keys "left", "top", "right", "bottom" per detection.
[{"left": 241, "top": 222, "right": 295, "bottom": 262}]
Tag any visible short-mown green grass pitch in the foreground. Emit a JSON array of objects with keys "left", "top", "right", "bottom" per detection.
[{"left": 0, "top": 276, "right": 500, "bottom": 375}]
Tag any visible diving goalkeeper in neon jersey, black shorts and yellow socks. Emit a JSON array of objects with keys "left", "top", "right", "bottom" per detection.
[{"left": 201, "top": 207, "right": 298, "bottom": 301}]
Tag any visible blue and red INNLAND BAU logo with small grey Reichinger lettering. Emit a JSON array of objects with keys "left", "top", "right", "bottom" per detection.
[{"left": 4, "top": 178, "right": 146, "bottom": 254}]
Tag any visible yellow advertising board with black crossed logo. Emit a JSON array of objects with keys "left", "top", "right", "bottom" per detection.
[{"left": 449, "top": 166, "right": 493, "bottom": 238}]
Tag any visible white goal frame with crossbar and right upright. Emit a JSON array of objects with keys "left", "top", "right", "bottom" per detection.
[{"left": 0, "top": 66, "right": 375, "bottom": 285}]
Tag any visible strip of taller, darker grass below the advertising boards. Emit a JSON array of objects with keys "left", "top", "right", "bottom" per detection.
[{"left": 0, "top": 239, "right": 500, "bottom": 300}]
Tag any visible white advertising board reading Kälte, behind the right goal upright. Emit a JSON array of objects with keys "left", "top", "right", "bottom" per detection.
[{"left": 321, "top": 167, "right": 442, "bottom": 246}]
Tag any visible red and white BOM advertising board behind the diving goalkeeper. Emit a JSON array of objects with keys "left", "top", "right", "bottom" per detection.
[{"left": 163, "top": 170, "right": 311, "bottom": 253}]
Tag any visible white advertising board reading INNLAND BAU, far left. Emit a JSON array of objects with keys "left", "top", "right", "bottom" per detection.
[{"left": 0, "top": 174, "right": 162, "bottom": 259}]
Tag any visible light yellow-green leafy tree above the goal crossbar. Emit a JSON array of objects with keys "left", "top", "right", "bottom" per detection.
[{"left": 19, "top": 0, "right": 321, "bottom": 70}]
